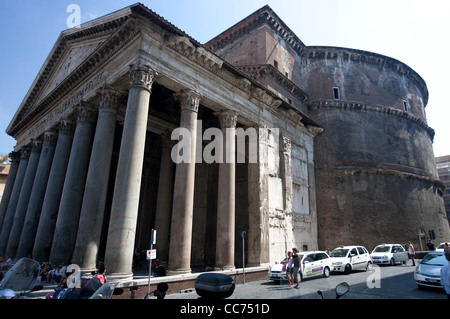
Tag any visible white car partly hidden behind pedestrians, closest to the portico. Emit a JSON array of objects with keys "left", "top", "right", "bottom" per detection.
[{"left": 268, "top": 251, "right": 333, "bottom": 281}]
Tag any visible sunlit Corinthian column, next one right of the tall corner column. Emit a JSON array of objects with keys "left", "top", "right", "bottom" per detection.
[{"left": 168, "top": 90, "right": 200, "bottom": 274}]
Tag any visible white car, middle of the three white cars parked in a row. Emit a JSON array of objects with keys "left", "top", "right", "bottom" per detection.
[{"left": 330, "top": 246, "right": 372, "bottom": 274}]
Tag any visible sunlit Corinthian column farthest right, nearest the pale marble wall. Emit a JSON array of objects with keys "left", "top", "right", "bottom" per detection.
[{"left": 215, "top": 110, "right": 237, "bottom": 269}]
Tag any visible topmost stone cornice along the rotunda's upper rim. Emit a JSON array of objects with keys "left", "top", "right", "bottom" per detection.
[{"left": 303, "top": 46, "right": 428, "bottom": 106}]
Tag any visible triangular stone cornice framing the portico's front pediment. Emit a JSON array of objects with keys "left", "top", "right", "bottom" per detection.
[{"left": 6, "top": 16, "right": 140, "bottom": 136}]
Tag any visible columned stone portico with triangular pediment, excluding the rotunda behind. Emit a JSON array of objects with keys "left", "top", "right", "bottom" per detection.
[{"left": 0, "top": 4, "right": 321, "bottom": 279}]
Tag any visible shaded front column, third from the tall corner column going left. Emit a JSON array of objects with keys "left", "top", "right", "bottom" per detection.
[{"left": 50, "top": 102, "right": 97, "bottom": 265}]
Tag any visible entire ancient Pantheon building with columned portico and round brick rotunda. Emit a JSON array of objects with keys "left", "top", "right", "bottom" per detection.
[{"left": 0, "top": 3, "right": 450, "bottom": 279}]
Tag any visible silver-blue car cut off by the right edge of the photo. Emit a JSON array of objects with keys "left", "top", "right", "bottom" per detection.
[{"left": 414, "top": 251, "right": 448, "bottom": 288}]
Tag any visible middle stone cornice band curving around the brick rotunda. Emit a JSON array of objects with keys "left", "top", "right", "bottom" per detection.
[{"left": 308, "top": 100, "right": 435, "bottom": 142}]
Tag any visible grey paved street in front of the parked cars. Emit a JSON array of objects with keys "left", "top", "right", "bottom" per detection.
[{"left": 166, "top": 265, "right": 447, "bottom": 299}]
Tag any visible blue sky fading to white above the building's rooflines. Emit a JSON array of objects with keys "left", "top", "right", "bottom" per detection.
[{"left": 0, "top": 0, "right": 450, "bottom": 156}]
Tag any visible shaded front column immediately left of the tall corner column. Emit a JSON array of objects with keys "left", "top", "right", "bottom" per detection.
[{"left": 72, "top": 86, "right": 121, "bottom": 271}]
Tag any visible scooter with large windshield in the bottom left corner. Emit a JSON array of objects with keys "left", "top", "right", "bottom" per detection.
[{"left": 0, "top": 257, "right": 43, "bottom": 299}]
